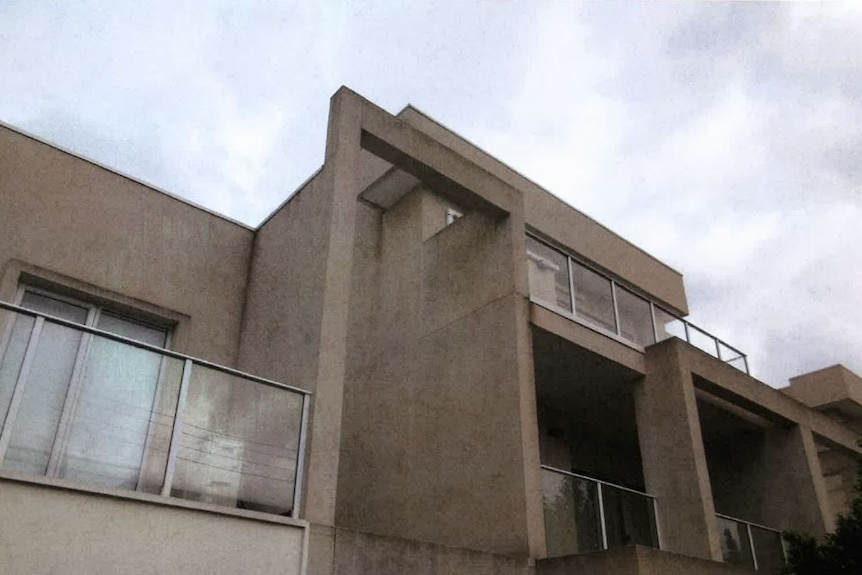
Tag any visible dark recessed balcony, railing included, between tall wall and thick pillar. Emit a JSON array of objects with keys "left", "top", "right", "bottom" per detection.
[{"left": 533, "top": 328, "right": 658, "bottom": 557}]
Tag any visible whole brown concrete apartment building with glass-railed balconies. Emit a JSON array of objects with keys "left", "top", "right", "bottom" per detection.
[{"left": 0, "top": 88, "right": 862, "bottom": 575}]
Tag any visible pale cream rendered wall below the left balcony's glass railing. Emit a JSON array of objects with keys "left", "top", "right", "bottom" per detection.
[{"left": 0, "top": 480, "right": 304, "bottom": 575}]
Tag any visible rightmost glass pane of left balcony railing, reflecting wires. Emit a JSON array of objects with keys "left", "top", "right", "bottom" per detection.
[{"left": 171, "top": 365, "right": 302, "bottom": 514}]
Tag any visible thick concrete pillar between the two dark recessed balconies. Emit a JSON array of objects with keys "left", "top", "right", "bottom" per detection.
[{"left": 635, "top": 339, "right": 721, "bottom": 561}]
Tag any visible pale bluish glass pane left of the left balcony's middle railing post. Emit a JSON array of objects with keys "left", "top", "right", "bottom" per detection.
[{"left": 55, "top": 335, "right": 183, "bottom": 493}]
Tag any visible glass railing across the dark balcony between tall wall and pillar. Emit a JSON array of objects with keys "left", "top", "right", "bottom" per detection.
[{"left": 542, "top": 465, "right": 660, "bottom": 557}]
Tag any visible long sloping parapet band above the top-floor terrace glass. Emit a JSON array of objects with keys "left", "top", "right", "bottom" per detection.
[{"left": 398, "top": 107, "right": 688, "bottom": 314}]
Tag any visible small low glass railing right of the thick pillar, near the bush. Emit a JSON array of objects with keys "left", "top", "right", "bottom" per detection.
[{"left": 716, "top": 513, "right": 785, "bottom": 575}]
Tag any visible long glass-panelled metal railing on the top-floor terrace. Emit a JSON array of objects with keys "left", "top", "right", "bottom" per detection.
[{"left": 527, "top": 235, "right": 750, "bottom": 373}]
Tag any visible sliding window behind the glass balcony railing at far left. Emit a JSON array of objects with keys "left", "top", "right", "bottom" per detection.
[{"left": 0, "top": 287, "right": 172, "bottom": 492}]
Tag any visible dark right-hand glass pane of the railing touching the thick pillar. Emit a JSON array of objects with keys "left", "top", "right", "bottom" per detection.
[{"left": 602, "top": 485, "right": 658, "bottom": 548}]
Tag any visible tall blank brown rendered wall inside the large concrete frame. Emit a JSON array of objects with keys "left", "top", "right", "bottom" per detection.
[{"left": 337, "top": 187, "right": 540, "bottom": 555}]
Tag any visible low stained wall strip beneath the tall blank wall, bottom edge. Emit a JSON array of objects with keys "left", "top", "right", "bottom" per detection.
[{"left": 333, "top": 529, "right": 534, "bottom": 575}]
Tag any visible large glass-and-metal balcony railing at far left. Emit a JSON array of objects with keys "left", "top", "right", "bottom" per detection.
[{"left": 0, "top": 302, "right": 310, "bottom": 517}]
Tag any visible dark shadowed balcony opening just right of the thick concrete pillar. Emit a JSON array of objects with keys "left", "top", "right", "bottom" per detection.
[{"left": 697, "top": 389, "right": 785, "bottom": 575}]
